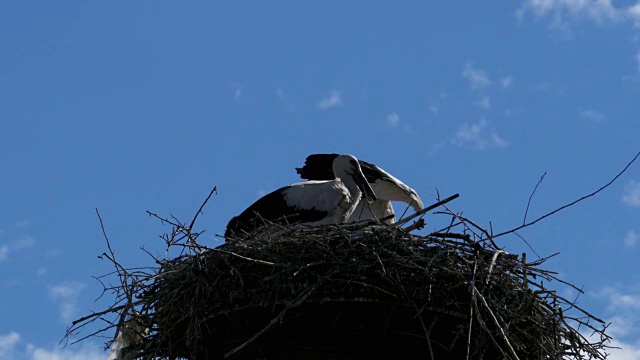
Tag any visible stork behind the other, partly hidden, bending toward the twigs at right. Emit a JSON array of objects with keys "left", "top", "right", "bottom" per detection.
[{"left": 296, "top": 154, "right": 424, "bottom": 224}]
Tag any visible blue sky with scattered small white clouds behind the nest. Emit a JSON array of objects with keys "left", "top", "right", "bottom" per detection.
[{"left": 0, "top": 0, "right": 640, "bottom": 360}]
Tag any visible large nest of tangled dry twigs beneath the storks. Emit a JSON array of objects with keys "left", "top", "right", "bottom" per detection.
[{"left": 69, "top": 191, "right": 609, "bottom": 359}]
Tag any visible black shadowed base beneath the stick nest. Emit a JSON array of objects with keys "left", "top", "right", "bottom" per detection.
[{"left": 198, "top": 301, "right": 476, "bottom": 359}]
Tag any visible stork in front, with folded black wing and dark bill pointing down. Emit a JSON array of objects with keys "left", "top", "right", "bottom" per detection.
[{"left": 224, "top": 154, "right": 376, "bottom": 237}]
